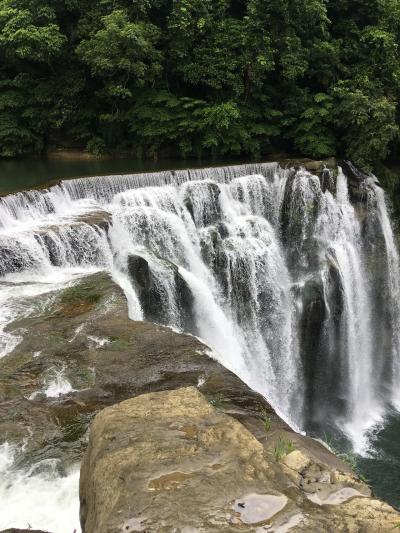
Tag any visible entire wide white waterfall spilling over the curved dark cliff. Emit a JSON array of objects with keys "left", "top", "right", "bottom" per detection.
[{"left": 0, "top": 159, "right": 400, "bottom": 526}]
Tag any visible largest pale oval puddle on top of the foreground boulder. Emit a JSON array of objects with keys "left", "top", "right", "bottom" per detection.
[{"left": 234, "top": 494, "right": 288, "bottom": 524}]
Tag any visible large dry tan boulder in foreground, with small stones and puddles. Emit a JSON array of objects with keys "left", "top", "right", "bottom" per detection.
[{"left": 80, "top": 387, "right": 399, "bottom": 533}]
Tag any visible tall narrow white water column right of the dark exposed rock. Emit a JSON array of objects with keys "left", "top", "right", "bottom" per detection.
[{"left": 319, "top": 171, "right": 383, "bottom": 453}]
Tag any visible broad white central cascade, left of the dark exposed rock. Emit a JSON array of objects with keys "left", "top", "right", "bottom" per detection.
[{"left": 108, "top": 175, "right": 298, "bottom": 414}]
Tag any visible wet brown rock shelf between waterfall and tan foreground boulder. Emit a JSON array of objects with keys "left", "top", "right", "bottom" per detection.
[{"left": 0, "top": 273, "right": 283, "bottom": 468}]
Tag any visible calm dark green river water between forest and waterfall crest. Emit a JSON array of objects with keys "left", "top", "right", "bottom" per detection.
[{"left": 0, "top": 155, "right": 245, "bottom": 194}]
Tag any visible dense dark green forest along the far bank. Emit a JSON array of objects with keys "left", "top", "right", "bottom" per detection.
[{"left": 0, "top": 0, "right": 400, "bottom": 169}]
